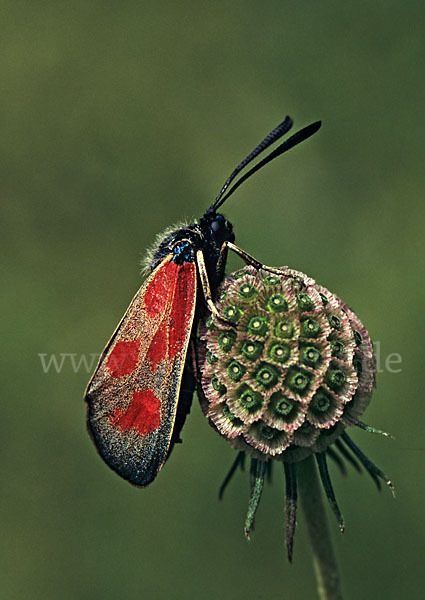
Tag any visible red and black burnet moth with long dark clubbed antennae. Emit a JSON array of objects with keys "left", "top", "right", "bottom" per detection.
[{"left": 85, "top": 117, "right": 321, "bottom": 486}]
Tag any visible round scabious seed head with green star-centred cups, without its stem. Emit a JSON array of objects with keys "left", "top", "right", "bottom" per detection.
[{"left": 198, "top": 267, "right": 376, "bottom": 462}]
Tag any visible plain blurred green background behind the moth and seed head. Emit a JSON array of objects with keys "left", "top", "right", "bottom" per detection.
[{"left": 0, "top": 0, "right": 425, "bottom": 600}]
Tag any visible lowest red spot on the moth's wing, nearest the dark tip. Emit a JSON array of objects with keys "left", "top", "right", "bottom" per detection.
[{"left": 110, "top": 390, "right": 161, "bottom": 435}]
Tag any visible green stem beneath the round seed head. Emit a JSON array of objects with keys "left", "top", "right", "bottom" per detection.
[{"left": 297, "top": 455, "right": 342, "bottom": 600}]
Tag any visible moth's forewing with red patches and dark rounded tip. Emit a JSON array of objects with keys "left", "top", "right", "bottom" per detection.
[{"left": 86, "top": 255, "right": 196, "bottom": 486}]
